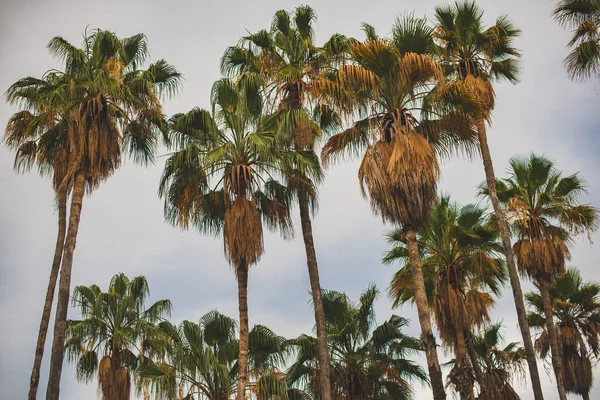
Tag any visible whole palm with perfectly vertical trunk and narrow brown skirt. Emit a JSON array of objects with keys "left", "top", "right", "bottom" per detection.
[{"left": 159, "top": 79, "right": 294, "bottom": 399}]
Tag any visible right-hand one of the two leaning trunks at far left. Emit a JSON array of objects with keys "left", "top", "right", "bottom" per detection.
[{"left": 46, "top": 172, "right": 85, "bottom": 400}]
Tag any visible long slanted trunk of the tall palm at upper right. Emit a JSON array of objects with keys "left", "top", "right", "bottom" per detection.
[{"left": 477, "top": 120, "right": 544, "bottom": 400}]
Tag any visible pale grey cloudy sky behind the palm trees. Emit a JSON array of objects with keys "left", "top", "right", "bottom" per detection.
[{"left": 0, "top": 0, "right": 600, "bottom": 400}]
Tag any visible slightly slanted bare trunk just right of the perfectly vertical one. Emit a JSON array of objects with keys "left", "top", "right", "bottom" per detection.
[{"left": 298, "top": 188, "right": 331, "bottom": 400}]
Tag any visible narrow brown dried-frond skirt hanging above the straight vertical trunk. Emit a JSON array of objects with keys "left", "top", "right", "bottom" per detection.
[{"left": 223, "top": 196, "right": 263, "bottom": 268}]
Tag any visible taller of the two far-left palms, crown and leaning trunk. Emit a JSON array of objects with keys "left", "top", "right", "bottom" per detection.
[{"left": 7, "top": 30, "right": 180, "bottom": 400}]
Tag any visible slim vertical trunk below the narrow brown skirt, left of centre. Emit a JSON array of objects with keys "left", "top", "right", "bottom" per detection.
[{"left": 236, "top": 258, "right": 249, "bottom": 400}]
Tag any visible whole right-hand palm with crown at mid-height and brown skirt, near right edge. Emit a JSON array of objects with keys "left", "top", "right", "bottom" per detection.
[{"left": 483, "top": 154, "right": 598, "bottom": 398}]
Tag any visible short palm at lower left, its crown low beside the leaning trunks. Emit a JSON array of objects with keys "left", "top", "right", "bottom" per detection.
[{"left": 66, "top": 273, "right": 171, "bottom": 400}]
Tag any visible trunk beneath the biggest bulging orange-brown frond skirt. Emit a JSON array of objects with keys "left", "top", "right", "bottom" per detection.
[{"left": 406, "top": 230, "right": 446, "bottom": 400}]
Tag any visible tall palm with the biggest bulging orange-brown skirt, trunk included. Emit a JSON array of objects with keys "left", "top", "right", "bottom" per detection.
[{"left": 322, "top": 16, "right": 476, "bottom": 400}]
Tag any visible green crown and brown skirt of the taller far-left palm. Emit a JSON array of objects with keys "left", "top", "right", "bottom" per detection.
[{"left": 6, "top": 29, "right": 181, "bottom": 189}]
